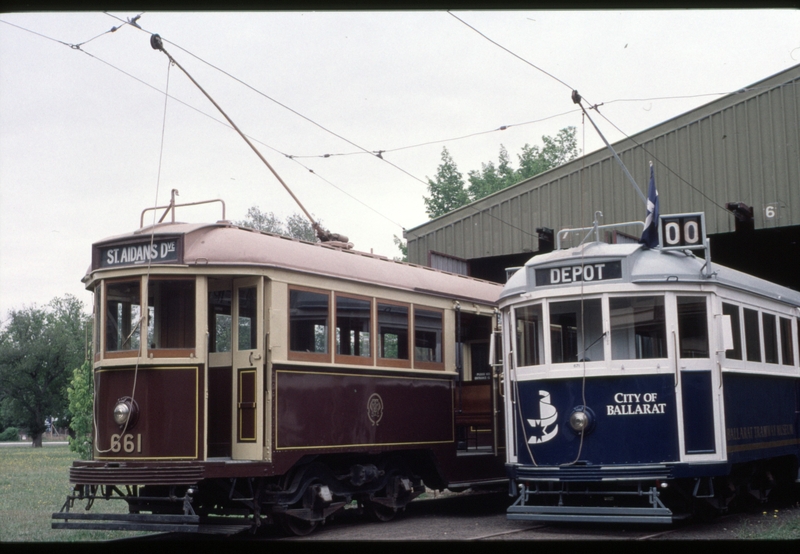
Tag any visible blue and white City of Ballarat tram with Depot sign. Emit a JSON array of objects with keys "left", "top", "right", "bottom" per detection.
[{"left": 500, "top": 214, "right": 800, "bottom": 523}]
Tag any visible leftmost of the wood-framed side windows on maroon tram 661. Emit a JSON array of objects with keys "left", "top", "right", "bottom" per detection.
[{"left": 289, "top": 290, "right": 328, "bottom": 354}]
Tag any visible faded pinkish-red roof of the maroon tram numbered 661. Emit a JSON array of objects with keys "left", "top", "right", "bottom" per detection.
[{"left": 84, "top": 221, "right": 502, "bottom": 305}]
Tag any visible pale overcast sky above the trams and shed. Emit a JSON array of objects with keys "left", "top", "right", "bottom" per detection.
[{"left": 0, "top": 10, "right": 800, "bottom": 314}]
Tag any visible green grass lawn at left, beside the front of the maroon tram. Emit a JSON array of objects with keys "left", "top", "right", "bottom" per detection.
[{"left": 0, "top": 443, "right": 147, "bottom": 542}]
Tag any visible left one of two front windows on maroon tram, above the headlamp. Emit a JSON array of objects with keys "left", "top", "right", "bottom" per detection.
[{"left": 105, "top": 280, "right": 142, "bottom": 352}]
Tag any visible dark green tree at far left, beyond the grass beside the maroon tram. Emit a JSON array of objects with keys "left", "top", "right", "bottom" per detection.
[{"left": 0, "top": 295, "right": 88, "bottom": 447}]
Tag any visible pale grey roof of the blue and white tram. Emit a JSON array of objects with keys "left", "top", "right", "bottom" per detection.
[{"left": 500, "top": 242, "right": 800, "bottom": 307}]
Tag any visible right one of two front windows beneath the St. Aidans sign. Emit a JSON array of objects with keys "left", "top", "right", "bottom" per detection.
[{"left": 147, "top": 279, "right": 195, "bottom": 348}]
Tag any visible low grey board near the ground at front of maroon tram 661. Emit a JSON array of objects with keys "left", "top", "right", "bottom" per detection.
[{"left": 51, "top": 512, "right": 200, "bottom": 533}]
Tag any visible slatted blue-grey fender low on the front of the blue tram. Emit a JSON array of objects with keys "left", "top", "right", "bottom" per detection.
[{"left": 507, "top": 478, "right": 674, "bottom": 524}]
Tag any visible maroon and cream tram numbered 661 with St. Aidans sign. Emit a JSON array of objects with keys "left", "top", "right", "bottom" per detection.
[{"left": 52, "top": 196, "right": 506, "bottom": 534}]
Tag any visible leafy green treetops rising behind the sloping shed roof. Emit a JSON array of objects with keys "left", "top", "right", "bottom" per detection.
[{"left": 424, "top": 127, "right": 579, "bottom": 219}]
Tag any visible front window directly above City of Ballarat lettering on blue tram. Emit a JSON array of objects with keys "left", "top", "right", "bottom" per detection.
[{"left": 609, "top": 296, "right": 667, "bottom": 360}]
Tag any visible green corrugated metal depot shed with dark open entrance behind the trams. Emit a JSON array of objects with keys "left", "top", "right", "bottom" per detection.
[{"left": 404, "top": 65, "right": 800, "bottom": 290}]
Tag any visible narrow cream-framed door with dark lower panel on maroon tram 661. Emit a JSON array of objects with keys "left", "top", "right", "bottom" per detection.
[{"left": 231, "top": 277, "right": 264, "bottom": 460}]
